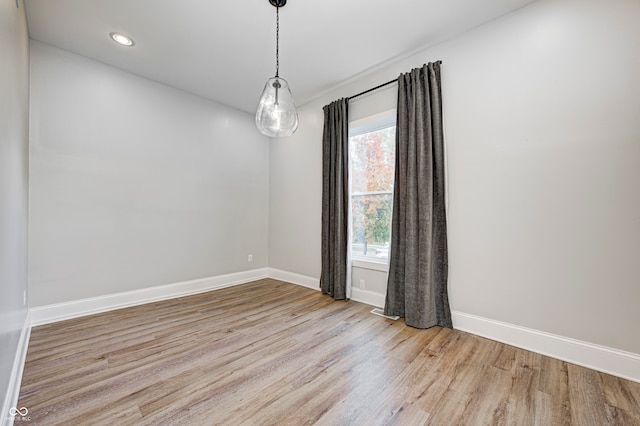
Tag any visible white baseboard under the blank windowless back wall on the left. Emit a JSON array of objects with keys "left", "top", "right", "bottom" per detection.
[{"left": 30, "top": 268, "right": 268, "bottom": 327}]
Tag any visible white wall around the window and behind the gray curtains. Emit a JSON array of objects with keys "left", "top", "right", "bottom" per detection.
[{"left": 269, "top": 0, "right": 640, "bottom": 354}]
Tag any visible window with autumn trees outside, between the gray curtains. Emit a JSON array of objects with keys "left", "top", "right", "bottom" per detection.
[{"left": 349, "top": 110, "right": 396, "bottom": 263}]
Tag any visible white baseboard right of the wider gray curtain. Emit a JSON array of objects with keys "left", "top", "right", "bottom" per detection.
[{"left": 451, "top": 311, "right": 640, "bottom": 383}]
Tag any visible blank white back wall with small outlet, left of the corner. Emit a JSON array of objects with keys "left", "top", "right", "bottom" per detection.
[{"left": 29, "top": 41, "right": 269, "bottom": 307}]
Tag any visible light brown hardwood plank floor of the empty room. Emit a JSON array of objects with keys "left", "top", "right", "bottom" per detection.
[{"left": 18, "top": 279, "right": 640, "bottom": 426}]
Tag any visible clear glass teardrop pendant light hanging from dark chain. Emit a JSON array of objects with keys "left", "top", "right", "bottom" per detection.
[{"left": 256, "top": 0, "right": 298, "bottom": 137}]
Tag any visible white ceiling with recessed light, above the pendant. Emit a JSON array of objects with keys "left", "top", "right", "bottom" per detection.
[{"left": 24, "top": 0, "right": 533, "bottom": 113}]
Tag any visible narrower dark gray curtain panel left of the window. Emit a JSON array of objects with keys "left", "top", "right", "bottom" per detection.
[{"left": 320, "top": 99, "right": 349, "bottom": 300}]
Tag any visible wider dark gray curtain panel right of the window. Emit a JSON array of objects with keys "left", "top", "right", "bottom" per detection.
[{"left": 384, "top": 62, "right": 452, "bottom": 328}]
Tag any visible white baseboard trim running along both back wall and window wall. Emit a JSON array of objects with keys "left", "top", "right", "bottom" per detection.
[{"left": 30, "top": 268, "right": 640, "bottom": 382}]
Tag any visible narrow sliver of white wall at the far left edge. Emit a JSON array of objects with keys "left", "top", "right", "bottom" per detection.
[{"left": 0, "top": 0, "right": 29, "bottom": 412}]
